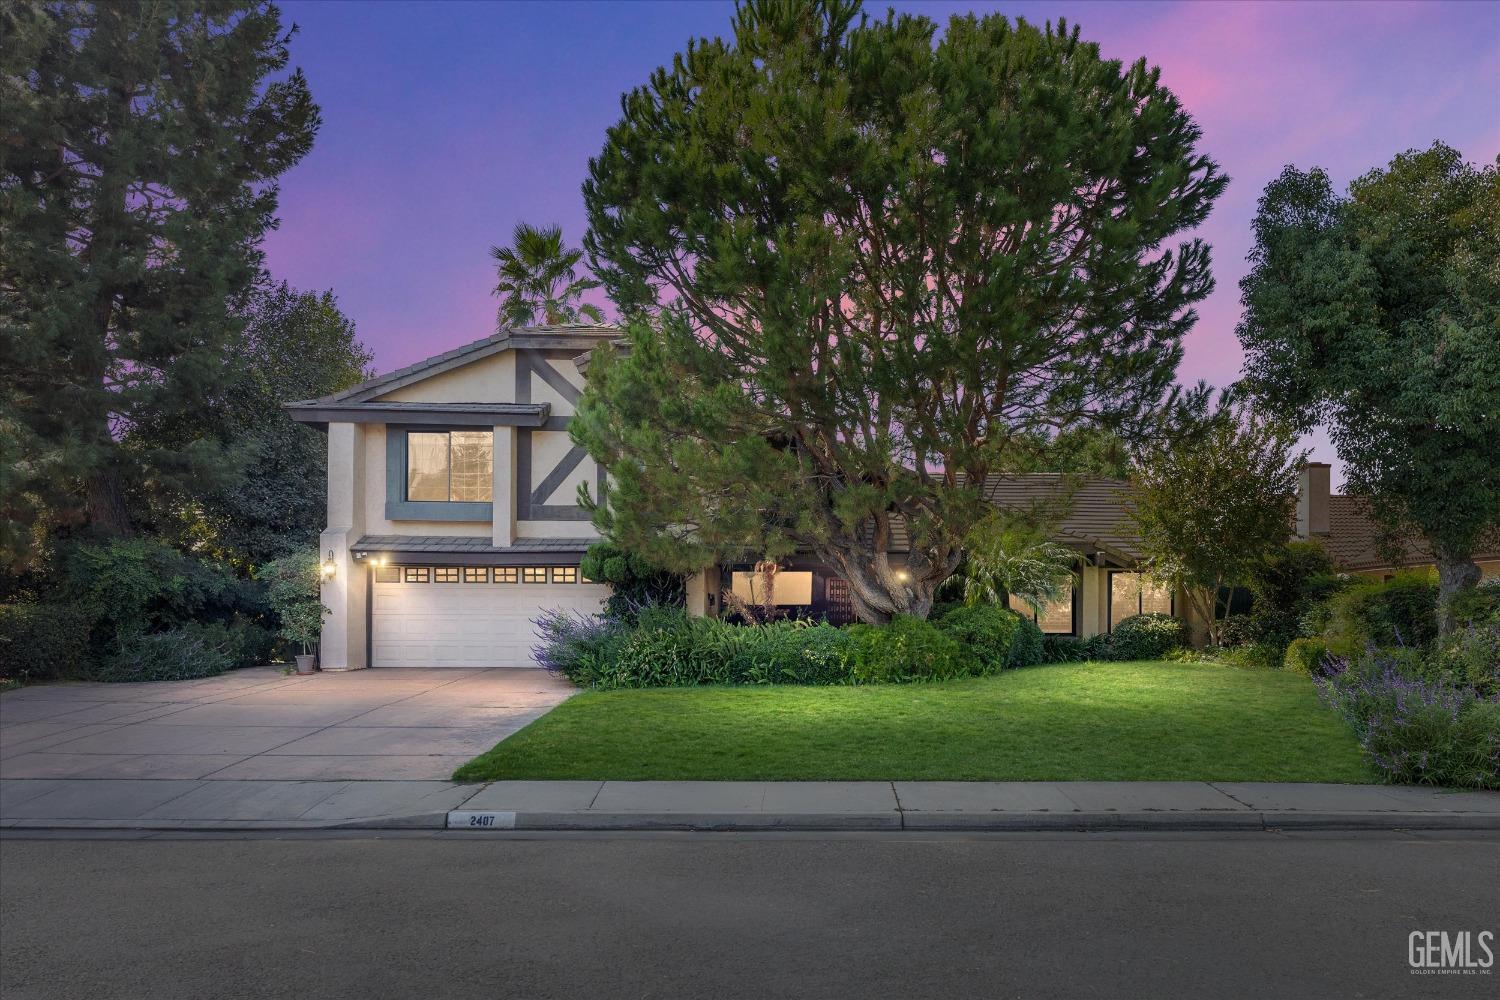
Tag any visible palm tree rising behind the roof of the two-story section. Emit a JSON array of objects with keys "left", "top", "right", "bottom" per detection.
[{"left": 489, "top": 222, "right": 605, "bottom": 327}]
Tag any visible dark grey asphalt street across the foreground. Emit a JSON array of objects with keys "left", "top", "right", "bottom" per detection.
[{"left": 0, "top": 834, "right": 1500, "bottom": 1000}]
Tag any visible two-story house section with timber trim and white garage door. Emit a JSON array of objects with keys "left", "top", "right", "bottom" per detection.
[{"left": 287, "top": 327, "right": 699, "bottom": 670}]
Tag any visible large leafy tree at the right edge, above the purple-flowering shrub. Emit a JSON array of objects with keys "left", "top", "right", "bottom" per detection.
[{"left": 1239, "top": 142, "right": 1500, "bottom": 630}]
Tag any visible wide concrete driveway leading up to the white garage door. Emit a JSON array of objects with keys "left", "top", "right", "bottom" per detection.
[{"left": 0, "top": 667, "right": 573, "bottom": 781}]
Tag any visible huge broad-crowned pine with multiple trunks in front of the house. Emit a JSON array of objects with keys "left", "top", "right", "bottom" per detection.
[{"left": 573, "top": 0, "right": 1224, "bottom": 622}]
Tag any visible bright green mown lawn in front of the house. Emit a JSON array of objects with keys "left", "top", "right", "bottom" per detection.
[{"left": 455, "top": 663, "right": 1377, "bottom": 783}]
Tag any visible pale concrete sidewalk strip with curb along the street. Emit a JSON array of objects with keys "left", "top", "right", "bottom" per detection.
[{"left": 0, "top": 778, "right": 1500, "bottom": 831}]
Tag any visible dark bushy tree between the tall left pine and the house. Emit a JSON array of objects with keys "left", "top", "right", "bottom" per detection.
[{"left": 126, "top": 282, "right": 374, "bottom": 568}]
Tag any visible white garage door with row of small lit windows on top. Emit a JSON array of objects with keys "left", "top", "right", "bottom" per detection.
[{"left": 371, "top": 567, "right": 609, "bottom": 667}]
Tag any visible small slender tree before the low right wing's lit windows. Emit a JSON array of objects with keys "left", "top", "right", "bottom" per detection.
[{"left": 1131, "top": 399, "right": 1307, "bottom": 645}]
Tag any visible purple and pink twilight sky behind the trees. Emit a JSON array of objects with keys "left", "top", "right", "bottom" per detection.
[{"left": 267, "top": 0, "right": 1500, "bottom": 481}]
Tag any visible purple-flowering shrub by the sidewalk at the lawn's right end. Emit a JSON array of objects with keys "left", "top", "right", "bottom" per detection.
[{"left": 1319, "top": 649, "right": 1500, "bottom": 789}]
